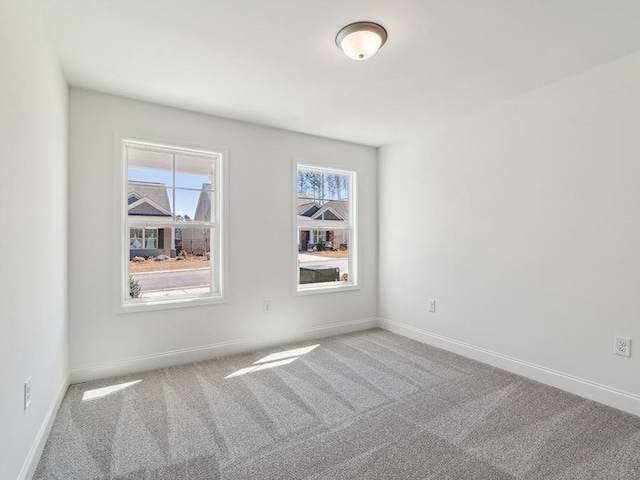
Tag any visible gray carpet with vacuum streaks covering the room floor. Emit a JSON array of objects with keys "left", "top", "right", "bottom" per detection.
[{"left": 34, "top": 329, "right": 640, "bottom": 480}]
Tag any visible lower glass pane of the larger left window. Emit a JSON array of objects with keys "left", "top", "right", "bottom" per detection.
[{"left": 128, "top": 228, "right": 213, "bottom": 298}]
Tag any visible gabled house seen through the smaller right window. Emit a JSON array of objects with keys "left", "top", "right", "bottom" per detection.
[{"left": 298, "top": 192, "right": 349, "bottom": 252}]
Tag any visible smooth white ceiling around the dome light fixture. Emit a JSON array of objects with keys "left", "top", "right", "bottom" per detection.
[{"left": 42, "top": 0, "right": 640, "bottom": 146}]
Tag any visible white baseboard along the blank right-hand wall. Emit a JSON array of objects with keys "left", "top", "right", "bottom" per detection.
[{"left": 378, "top": 319, "right": 640, "bottom": 416}]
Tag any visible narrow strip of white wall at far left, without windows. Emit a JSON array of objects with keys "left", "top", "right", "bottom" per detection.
[{"left": 0, "top": 0, "right": 67, "bottom": 479}]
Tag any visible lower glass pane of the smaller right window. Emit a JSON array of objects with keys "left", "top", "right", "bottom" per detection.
[{"left": 298, "top": 230, "right": 349, "bottom": 285}]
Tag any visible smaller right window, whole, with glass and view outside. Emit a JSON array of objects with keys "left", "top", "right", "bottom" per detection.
[{"left": 296, "top": 164, "right": 357, "bottom": 292}]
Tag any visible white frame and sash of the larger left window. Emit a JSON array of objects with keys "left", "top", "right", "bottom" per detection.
[{"left": 115, "top": 134, "right": 229, "bottom": 313}]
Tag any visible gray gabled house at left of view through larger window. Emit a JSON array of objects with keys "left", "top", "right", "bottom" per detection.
[{"left": 128, "top": 181, "right": 175, "bottom": 258}]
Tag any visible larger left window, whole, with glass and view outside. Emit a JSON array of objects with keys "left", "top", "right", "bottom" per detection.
[{"left": 120, "top": 140, "right": 224, "bottom": 309}]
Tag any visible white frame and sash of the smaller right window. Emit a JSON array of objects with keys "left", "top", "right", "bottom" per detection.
[{"left": 292, "top": 163, "right": 360, "bottom": 295}]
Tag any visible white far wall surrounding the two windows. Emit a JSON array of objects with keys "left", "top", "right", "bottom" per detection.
[{"left": 69, "top": 89, "right": 377, "bottom": 381}]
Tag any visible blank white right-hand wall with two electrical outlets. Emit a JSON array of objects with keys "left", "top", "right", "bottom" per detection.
[{"left": 379, "top": 50, "right": 640, "bottom": 414}]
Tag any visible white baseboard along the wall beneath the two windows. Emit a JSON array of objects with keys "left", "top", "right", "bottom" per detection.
[{"left": 70, "top": 317, "right": 378, "bottom": 383}]
